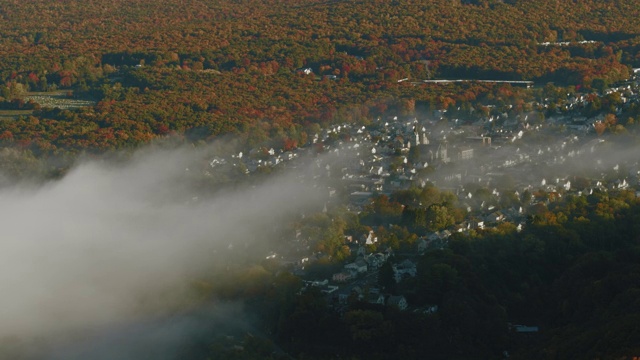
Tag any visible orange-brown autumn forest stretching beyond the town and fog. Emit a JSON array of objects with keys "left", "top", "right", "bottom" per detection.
[{"left": 0, "top": 0, "right": 640, "bottom": 156}]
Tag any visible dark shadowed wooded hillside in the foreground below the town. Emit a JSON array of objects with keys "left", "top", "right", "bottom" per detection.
[{"left": 176, "top": 189, "right": 640, "bottom": 360}]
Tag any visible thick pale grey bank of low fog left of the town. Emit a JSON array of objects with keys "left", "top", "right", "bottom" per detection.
[{"left": 0, "top": 143, "right": 322, "bottom": 339}]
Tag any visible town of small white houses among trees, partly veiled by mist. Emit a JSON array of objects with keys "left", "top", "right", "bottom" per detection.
[{"left": 200, "top": 69, "right": 640, "bottom": 316}]
